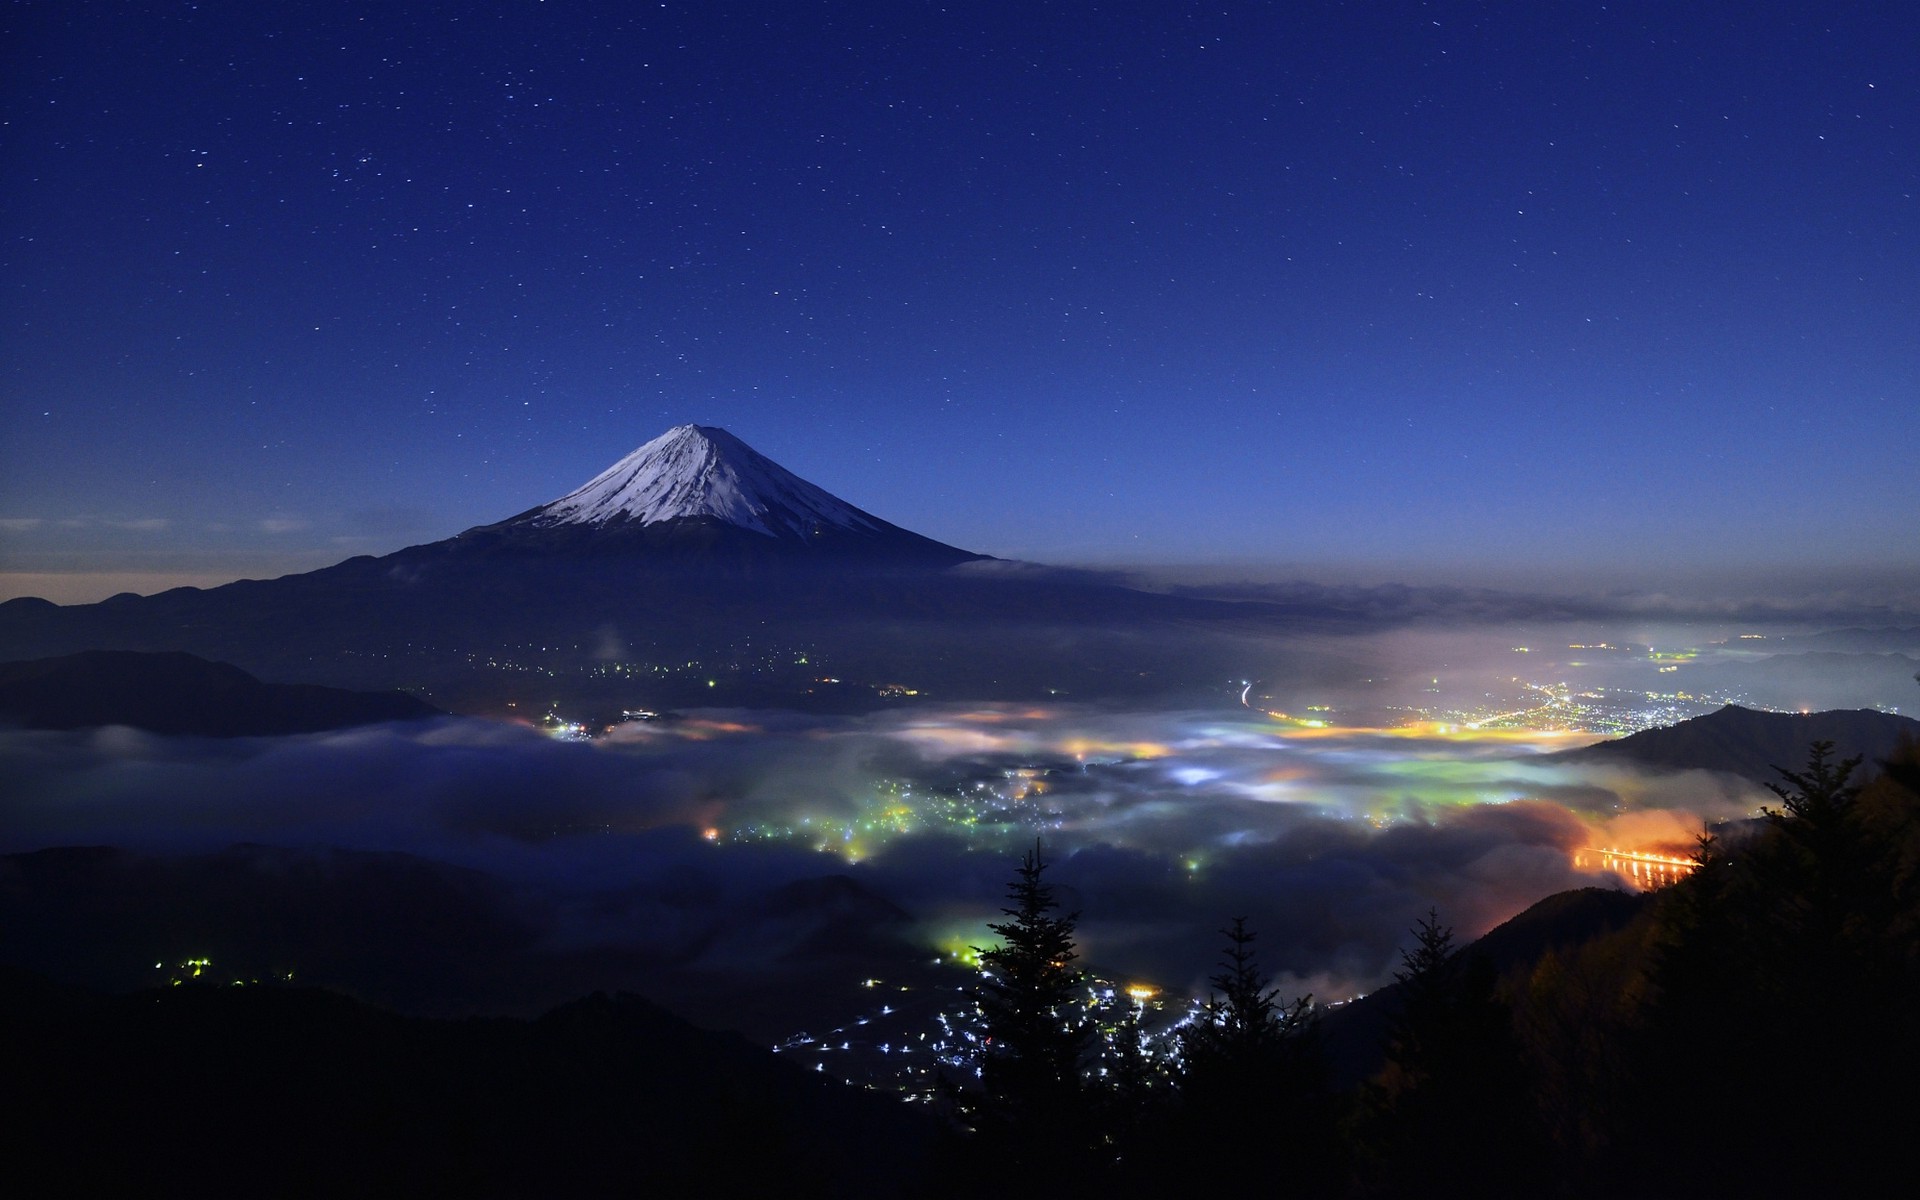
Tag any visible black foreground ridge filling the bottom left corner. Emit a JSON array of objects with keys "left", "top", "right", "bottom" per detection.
[{"left": 0, "top": 970, "right": 935, "bottom": 1196}]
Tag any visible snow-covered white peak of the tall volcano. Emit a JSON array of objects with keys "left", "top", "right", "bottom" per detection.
[{"left": 518, "top": 424, "right": 891, "bottom": 538}]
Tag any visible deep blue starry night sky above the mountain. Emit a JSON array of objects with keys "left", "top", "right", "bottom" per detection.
[{"left": 0, "top": 0, "right": 1920, "bottom": 601}]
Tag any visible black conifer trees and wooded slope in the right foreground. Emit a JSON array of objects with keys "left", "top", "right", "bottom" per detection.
[{"left": 929, "top": 743, "right": 1920, "bottom": 1198}]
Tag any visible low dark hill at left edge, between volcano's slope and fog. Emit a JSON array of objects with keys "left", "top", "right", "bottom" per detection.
[{"left": 0, "top": 651, "right": 444, "bottom": 737}]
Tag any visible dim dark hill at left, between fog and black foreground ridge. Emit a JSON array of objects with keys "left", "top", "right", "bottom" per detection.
[{"left": 0, "top": 845, "right": 541, "bottom": 1014}]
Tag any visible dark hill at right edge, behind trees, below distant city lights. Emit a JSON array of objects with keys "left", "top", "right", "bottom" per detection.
[{"left": 1555, "top": 705, "right": 1920, "bottom": 783}]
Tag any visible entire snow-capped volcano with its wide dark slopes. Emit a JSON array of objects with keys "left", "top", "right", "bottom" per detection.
[{"left": 0, "top": 426, "right": 1327, "bottom": 714}]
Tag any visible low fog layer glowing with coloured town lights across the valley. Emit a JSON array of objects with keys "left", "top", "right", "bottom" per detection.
[{"left": 0, "top": 691, "right": 1759, "bottom": 998}]
